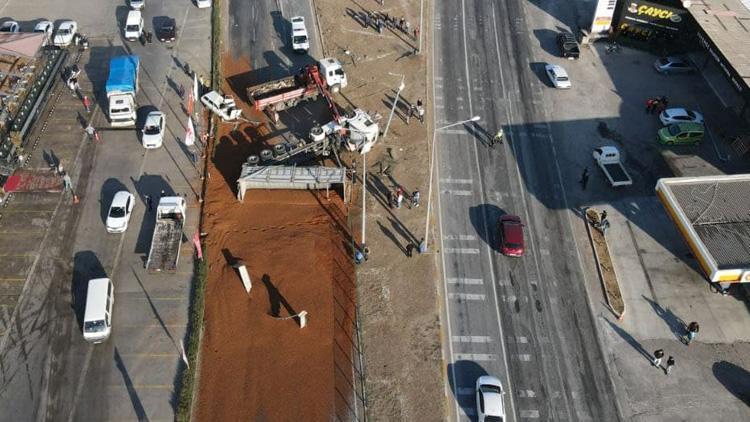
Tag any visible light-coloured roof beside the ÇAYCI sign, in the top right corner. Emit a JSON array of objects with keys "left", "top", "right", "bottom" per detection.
[{"left": 687, "top": 0, "right": 750, "bottom": 94}]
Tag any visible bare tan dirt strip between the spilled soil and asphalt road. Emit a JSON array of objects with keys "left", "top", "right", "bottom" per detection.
[{"left": 314, "top": 0, "right": 445, "bottom": 420}]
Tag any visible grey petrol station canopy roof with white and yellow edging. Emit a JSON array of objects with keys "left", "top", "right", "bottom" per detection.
[{"left": 659, "top": 174, "right": 750, "bottom": 269}]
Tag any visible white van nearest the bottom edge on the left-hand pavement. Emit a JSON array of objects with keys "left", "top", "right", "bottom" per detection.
[{"left": 83, "top": 278, "right": 115, "bottom": 343}]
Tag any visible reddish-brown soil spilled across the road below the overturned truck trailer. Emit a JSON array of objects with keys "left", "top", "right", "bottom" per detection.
[{"left": 196, "top": 57, "right": 355, "bottom": 421}]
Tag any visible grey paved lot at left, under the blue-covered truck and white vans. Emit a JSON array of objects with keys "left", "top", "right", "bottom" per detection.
[{"left": 0, "top": 0, "right": 211, "bottom": 420}]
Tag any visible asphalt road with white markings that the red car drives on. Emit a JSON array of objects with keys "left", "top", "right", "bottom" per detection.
[{"left": 432, "top": 0, "right": 619, "bottom": 421}]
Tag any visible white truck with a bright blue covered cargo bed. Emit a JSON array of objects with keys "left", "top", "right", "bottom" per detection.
[{"left": 106, "top": 56, "right": 140, "bottom": 127}]
